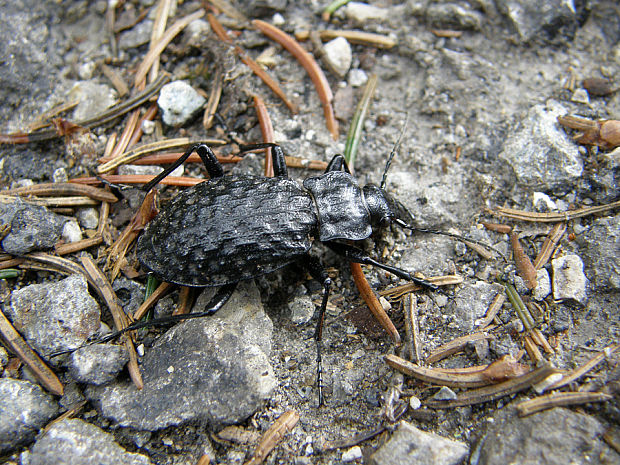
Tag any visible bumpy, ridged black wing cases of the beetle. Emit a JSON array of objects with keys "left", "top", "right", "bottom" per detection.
[{"left": 138, "top": 176, "right": 317, "bottom": 286}]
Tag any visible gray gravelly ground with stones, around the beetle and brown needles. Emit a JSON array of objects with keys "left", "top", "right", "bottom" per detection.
[{"left": 0, "top": 0, "right": 620, "bottom": 465}]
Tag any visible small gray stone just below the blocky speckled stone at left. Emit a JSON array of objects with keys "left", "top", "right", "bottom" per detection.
[{"left": 67, "top": 344, "right": 129, "bottom": 386}]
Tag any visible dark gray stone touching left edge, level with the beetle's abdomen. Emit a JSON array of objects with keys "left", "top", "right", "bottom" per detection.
[{"left": 0, "top": 198, "right": 67, "bottom": 255}]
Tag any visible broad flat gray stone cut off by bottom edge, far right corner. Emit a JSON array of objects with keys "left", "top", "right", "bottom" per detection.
[{"left": 478, "top": 408, "right": 605, "bottom": 465}]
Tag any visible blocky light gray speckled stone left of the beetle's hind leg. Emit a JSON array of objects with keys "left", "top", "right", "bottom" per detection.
[{"left": 5, "top": 274, "right": 100, "bottom": 354}]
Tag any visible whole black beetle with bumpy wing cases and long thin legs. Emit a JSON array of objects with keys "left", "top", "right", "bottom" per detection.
[{"left": 136, "top": 144, "right": 435, "bottom": 405}]
